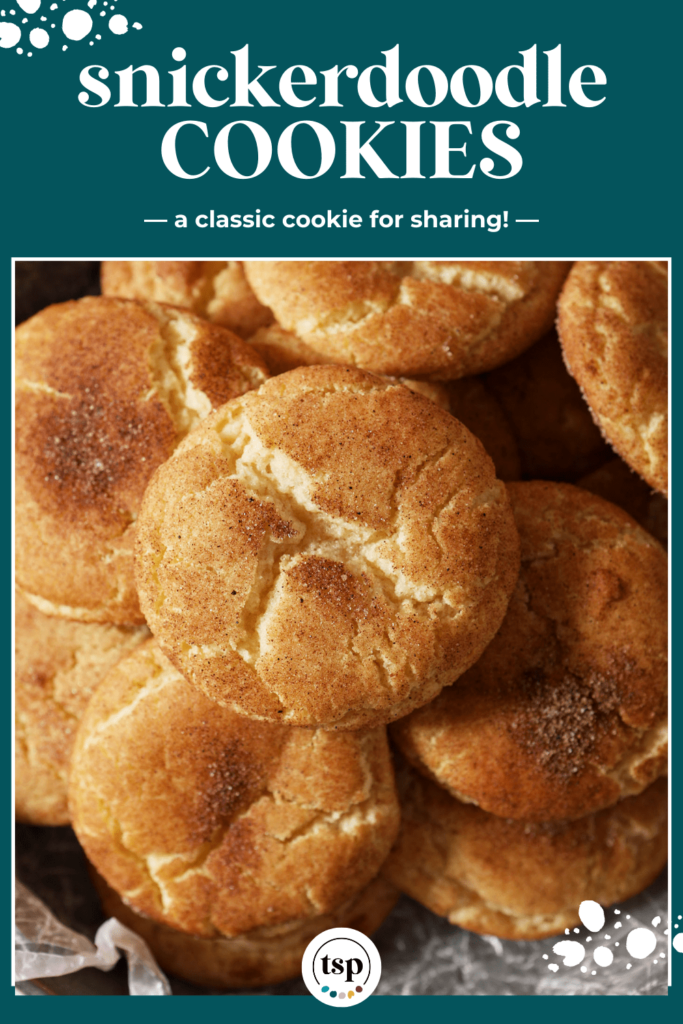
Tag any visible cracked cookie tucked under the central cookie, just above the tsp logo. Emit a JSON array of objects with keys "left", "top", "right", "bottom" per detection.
[{"left": 70, "top": 641, "right": 399, "bottom": 938}]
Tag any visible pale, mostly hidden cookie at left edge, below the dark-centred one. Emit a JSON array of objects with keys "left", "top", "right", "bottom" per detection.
[{"left": 14, "top": 594, "right": 150, "bottom": 825}]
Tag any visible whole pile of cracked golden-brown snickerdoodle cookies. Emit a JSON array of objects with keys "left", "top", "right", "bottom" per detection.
[{"left": 16, "top": 261, "right": 668, "bottom": 988}]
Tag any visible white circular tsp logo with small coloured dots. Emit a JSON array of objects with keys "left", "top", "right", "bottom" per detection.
[{"left": 301, "top": 928, "right": 382, "bottom": 1007}]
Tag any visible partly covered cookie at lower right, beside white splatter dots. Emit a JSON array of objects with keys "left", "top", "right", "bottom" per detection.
[{"left": 382, "top": 770, "right": 668, "bottom": 939}]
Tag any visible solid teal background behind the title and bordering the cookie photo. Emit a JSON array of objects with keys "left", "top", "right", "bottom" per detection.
[{"left": 0, "top": 0, "right": 683, "bottom": 1021}]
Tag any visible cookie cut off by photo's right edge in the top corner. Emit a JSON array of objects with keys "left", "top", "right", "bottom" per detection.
[{"left": 557, "top": 260, "right": 669, "bottom": 496}]
